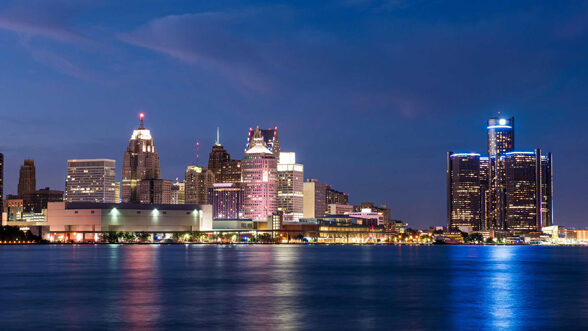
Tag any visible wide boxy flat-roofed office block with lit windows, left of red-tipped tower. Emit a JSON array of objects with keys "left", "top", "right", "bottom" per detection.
[{"left": 65, "top": 159, "right": 118, "bottom": 203}]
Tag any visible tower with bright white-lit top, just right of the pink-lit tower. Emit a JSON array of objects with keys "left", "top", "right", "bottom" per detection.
[{"left": 278, "top": 152, "right": 304, "bottom": 221}]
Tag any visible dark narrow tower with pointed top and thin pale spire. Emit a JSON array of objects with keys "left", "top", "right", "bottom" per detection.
[{"left": 208, "top": 128, "right": 241, "bottom": 183}]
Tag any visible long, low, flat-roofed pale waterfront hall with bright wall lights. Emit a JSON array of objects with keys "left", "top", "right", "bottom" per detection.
[{"left": 47, "top": 202, "right": 212, "bottom": 236}]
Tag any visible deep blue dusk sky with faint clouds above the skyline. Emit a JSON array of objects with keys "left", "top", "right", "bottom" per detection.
[{"left": 0, "top": 0, "right": 588, "bottom": 227}]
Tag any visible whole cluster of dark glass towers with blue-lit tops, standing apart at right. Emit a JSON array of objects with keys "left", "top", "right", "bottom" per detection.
[{"left": 447, "top": 117, "right": 553, "bottom": 233}]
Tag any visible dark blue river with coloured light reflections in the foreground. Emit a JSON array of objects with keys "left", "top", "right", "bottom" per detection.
[{"left": 0, "top": 245, "right": 588, "bottom": 330}]
